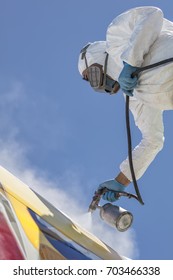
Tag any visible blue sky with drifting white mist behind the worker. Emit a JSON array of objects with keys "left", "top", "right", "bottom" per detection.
[{"left": 0, "top": 0, "right": 173, "bottom": 259}]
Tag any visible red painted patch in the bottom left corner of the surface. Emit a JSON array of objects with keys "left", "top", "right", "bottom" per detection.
[{"left": 0, "top": 212, "right": 24, "bottom": 260}]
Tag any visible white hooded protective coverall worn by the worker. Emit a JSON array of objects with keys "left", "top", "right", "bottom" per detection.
[{"left": 78, "top": 6, "right": 173, "bottom": 181}]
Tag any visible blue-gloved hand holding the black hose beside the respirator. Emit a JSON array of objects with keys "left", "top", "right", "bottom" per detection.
[{"left": 118, "top": 62, "right": 138, "bottom": 96}]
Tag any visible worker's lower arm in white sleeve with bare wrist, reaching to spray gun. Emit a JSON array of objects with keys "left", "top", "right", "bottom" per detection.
[{"left": 118, "top": 98, "right": 164, "bottom": 184}]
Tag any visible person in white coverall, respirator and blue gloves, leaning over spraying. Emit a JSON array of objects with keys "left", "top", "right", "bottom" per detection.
[{"left": 78, "top": 6, "right": 173, "bottom": 202}]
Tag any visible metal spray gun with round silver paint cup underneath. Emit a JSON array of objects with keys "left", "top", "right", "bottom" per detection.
[{"left": 88, "top": 188, "right": 138, "bottom": 231}]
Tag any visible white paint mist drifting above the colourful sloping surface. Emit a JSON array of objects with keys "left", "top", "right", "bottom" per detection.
[{"left": 0, "top": 80, "right": 138, "bottom": 258}]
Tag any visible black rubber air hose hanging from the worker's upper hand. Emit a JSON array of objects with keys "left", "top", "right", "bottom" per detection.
[{"left": 126, "top": 57, "right": 173, "bottom": 205}]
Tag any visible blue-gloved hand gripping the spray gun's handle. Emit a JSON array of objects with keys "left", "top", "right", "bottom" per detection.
[{"left": 98, "top": 179, "right": 125, "bottom": 202}]
